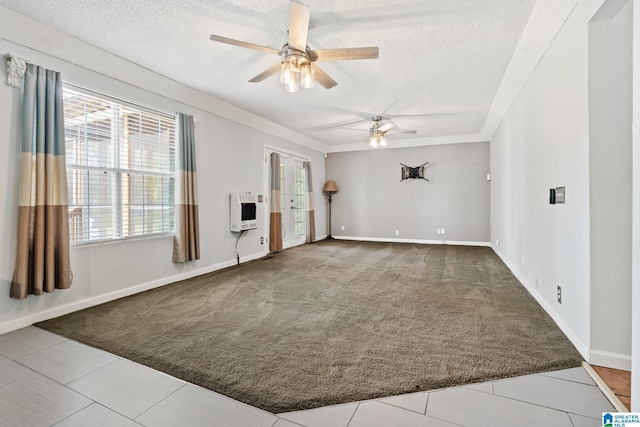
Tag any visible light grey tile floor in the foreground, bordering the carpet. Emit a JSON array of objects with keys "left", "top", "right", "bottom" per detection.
[{"left": 0, "top": 326, "right": 614, "bottom": 427}]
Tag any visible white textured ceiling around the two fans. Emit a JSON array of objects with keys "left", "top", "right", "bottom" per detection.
[{"left": 0, "top": 0, "right": 536, "bottom": 148}]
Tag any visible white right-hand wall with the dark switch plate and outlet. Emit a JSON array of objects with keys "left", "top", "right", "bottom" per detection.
[{"left": 491, "top": 0, "right": 631, "bottom": 368}]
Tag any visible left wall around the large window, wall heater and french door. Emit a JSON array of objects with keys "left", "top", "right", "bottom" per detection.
[{"left": 0, "top": 8, "right": 325, "bottom": 333}]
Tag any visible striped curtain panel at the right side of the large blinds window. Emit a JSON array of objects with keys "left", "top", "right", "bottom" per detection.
[{"left": 173, "top": 113, "right": 200, "bottom": 263}]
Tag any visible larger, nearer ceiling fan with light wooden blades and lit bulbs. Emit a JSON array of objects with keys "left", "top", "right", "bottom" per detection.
[{"left": 209, "top": 1, "right": 378, "bottom": 92}]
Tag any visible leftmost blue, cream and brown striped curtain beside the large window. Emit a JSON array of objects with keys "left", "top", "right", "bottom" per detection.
[{"left": 10, "top": 64, "right": 72, "bottom": 299}]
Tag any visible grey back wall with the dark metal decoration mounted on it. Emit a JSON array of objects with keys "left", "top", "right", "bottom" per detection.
[{"left": 326, "top": 141, "right": 490, "bottom": 244}]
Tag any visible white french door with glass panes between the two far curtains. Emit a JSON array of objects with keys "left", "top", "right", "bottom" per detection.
[{"left": 280, "top": 154, "right": 307, "bottom": 249}]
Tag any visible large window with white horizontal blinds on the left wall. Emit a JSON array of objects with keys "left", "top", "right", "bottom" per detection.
[{"left": 63, "top": 86, "right": 175, "bottom": 244}]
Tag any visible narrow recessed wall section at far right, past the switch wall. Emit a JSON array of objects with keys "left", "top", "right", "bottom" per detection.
[{"left": 589, "top": 0, "right": 633, "bottom": 369}]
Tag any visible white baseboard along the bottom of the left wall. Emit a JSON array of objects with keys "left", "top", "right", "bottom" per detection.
[{"left": 0, "top": 251, "right": 268, "bottom": 334}]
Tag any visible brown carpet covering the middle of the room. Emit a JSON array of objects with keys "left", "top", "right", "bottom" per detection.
[{"left": 37, "top": 241, "right": 581, "bottom": 413}]
